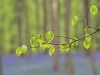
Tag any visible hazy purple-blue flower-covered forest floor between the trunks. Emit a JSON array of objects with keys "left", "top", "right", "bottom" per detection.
[{"left": 2, "top": 52, "right": 100, "bottom": 75}]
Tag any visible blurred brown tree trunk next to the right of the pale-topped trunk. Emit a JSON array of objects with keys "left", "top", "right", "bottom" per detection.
[{"left": 65, "top": 0, "right": 73, "bottom": 75}]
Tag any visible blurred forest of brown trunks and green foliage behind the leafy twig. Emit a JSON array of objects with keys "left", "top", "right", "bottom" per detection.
[{"left": 0, "top": 0, "right": 100, "bottom": 75}]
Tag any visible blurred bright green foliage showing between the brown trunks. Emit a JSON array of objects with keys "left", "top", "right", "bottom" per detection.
[{"left": 0, "top": 0, "right": 100, "bottom": 54}]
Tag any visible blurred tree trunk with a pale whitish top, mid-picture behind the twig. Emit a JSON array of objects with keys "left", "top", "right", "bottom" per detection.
[{"left": 51, "top": 0, "right": 60, "bottom": 75}]
